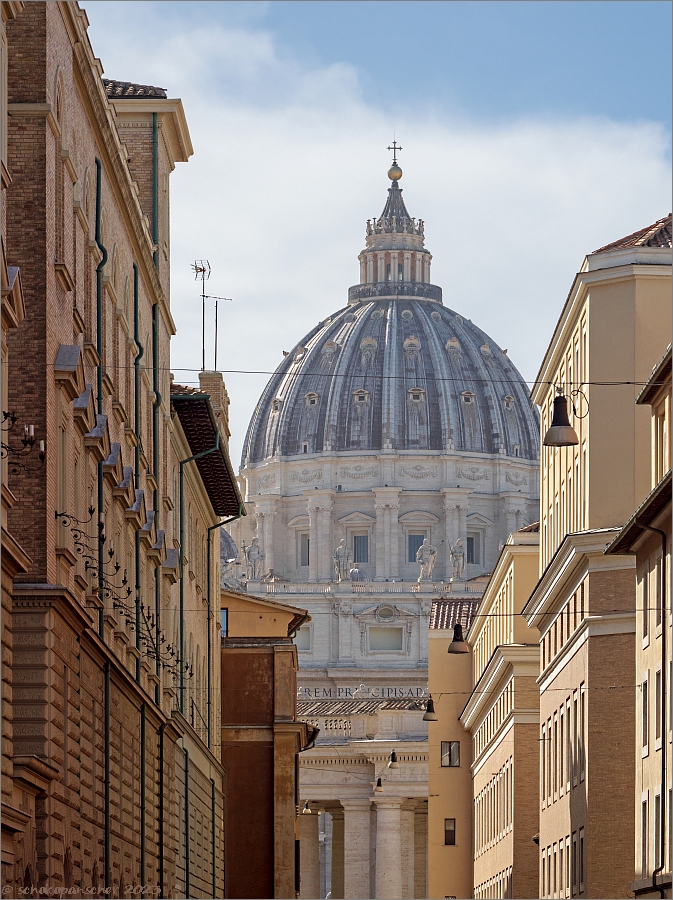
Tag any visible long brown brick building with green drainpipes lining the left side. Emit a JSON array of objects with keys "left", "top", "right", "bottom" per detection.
[{"left": 2, "top": 2, "right": 243, "bottom": 897}]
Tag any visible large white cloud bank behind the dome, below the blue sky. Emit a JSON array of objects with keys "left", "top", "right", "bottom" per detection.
[{"left": 87, "top": 3, "right": 671, "bottom": 468}]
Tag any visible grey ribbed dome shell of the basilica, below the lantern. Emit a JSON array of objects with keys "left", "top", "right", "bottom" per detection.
[{"left": 243, "top": 298, "right": 539, "bottom": 466}]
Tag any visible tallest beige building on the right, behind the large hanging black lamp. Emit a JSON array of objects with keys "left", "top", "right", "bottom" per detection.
[{"left": 524, "top": 216, "right": 671, "bottom": 897}]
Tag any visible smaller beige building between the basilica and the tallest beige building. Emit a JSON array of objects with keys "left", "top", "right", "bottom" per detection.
[{"left": 460, "top": 524, "right": 539, "bottom": 897}]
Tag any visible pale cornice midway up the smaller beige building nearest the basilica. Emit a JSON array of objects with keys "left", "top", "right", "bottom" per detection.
[{"left": 459, "top": 644, "right": 540, "bottom": 732}]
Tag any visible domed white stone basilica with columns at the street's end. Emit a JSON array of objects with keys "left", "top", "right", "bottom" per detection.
[{"left": 227, "top": 161, "right": 539, "bottom": 897}]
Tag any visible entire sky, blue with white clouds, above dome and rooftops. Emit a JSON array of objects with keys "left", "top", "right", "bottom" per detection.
[{"left": 83, "top": 0, "right": 671, "bottom": 458}]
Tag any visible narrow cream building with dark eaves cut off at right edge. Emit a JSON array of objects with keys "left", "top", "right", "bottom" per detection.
[{"left": 606, "top": 345, "right": 672, "bottom": 897}]
